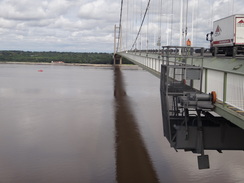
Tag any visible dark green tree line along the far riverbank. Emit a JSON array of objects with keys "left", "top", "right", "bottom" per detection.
[{"left": 0, "top": 51, "right": 131, "bottom": 64}]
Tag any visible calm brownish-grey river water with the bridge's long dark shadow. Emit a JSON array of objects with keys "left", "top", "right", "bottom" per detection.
[{"left": 0, "top": 64, "right": 244, "bottom": 183}]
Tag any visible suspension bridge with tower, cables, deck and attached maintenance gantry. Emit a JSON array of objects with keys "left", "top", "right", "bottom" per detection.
[{"left": 114, "top": 0, "right": 244, "bottom": 169}]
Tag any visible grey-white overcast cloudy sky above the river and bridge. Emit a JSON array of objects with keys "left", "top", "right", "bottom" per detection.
[{"left": 0, "top": 0, "right": 243, "bottom": 52}]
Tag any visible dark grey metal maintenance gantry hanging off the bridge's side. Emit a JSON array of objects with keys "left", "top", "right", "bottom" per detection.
[{"left": 160, "top": 46, "right": 244, "bottom": 169}]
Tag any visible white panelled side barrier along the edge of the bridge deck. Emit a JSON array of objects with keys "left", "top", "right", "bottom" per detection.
[{"left": 120, "top": 50, "right": 244, "bottom": 111}]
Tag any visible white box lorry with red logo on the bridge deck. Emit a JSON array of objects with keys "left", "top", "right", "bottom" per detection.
[{"left": 206, "top": 14, "right": 244, "bottom": 56}]
